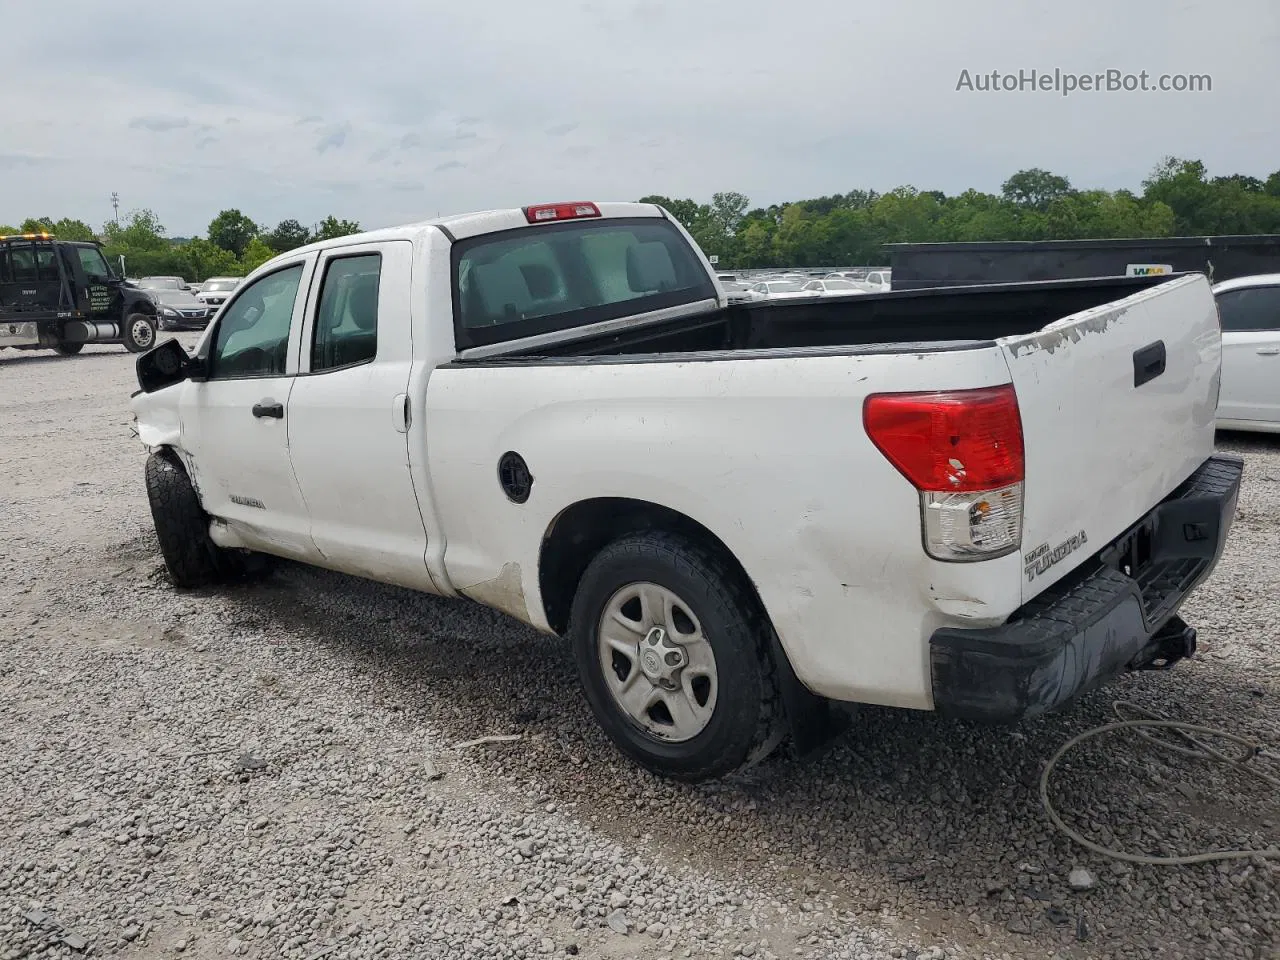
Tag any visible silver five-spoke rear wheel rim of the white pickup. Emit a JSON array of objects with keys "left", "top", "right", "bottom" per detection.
[{"left": 596, "top": 582, "right": 719, "bottom": 744}]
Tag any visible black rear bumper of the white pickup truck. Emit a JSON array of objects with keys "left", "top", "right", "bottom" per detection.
[{"left": 929, "top": 456, "right": 1244, "bottom": 722}]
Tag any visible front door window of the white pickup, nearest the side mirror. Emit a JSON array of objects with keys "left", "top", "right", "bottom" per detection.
[{"left": 209, "top": 264, "right": 302, "bottom": 380}]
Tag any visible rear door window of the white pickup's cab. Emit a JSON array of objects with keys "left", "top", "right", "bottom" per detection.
[{"left": 311, "top": 253, "right": 383, "bottom": 372}]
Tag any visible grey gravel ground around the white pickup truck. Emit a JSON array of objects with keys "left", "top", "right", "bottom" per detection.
[{"left": 0, "top": 337, "right": 1280, "bottom": 960}]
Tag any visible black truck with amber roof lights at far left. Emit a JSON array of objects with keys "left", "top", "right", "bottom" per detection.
[{"left": 0, "top": 233, "right": 156, "bottom": 356}]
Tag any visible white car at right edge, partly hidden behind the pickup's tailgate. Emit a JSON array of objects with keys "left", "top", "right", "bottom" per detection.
[{"left": 1213, "top": 274, "right": 1280, "bottom": 433}]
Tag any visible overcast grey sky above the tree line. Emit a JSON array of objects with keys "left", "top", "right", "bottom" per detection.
[{"left": 0, "top": 0, "right": 1280, "bottom": 236}]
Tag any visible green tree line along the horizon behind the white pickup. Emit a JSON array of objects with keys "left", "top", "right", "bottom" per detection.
[{"left": 10, "top": 156, "right": 1280, "bottom": 280}]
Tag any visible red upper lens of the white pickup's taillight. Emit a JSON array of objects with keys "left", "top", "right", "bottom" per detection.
[{"left": 863, "top": 384, "right": 1024, "bottom": 493}]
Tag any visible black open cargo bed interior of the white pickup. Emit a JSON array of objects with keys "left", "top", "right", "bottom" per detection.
[{"left": 474, "top": 276, "right": 1171, "bottom": 365}]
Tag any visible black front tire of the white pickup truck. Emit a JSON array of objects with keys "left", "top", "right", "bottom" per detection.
[{"left": 146, "top": 453, "right": 269, "bottom": 590}]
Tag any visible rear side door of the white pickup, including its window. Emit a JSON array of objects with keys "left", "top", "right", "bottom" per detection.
[{"left": 289, "top": 241, "right": 434, "bottom": 590}]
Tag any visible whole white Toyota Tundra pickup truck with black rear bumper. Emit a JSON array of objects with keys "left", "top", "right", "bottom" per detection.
[{"left": 132, "top": 204, "right": 1242, "bottom": 781}]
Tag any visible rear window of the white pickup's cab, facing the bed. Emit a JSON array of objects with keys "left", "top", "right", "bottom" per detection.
[{"left": 452, "top": 218, "right": 716, "bottom": 349}]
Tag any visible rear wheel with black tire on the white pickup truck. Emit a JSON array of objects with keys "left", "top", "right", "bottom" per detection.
[{"left": 568, "top": 532, "right": 783, "bottom": 782}]
